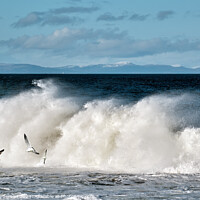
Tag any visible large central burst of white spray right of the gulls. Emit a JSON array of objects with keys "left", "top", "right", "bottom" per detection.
[{"left": 50, "top": 95, "right": 177, "bottom": 171}]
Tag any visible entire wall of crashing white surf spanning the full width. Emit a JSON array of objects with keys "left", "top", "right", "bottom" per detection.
[{"left": 0, "top": 81, "right": 200, "bottom": 173}]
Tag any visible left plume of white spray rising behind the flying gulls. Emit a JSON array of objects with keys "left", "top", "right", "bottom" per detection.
[{"left": 0, "top": 81, "right": 78, "bottom": 166}]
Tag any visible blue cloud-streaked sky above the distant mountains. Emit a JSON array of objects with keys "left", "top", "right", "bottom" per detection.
[{"left": 0, "top": 0, "right": 200, "bottom": 68}]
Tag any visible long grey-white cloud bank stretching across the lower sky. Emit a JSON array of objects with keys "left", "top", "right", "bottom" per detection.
[{"left": 0, "top": 28, "right": 200, "bottom": 58}]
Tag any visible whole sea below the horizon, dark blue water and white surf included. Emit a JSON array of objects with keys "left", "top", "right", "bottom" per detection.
[{"left": 0, "top": 74, "right": 200, "bottom": 200}]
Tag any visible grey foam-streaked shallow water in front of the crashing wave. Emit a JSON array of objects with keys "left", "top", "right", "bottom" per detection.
[{"left": 0, "top": 167, "right": 200, "bottom": 200}]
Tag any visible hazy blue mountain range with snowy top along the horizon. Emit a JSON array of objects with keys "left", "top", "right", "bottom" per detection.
[{"left": 0, "top": 63, "right": 200, "bottom": 74}]
